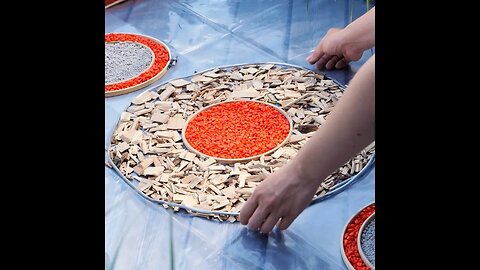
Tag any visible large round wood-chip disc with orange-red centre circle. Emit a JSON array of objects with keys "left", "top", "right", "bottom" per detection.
[{"left": 108, "top": 63, "right": 375, "bottom": 222}]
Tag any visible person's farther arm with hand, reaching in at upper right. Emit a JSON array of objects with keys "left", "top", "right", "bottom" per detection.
[{"left": 307, "top": 7, "right": 375, "bottom": 69}]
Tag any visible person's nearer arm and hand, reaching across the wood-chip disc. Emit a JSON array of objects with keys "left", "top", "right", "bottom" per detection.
[{"left": 240, "top": 55, "right": 375, "bottom": 233}]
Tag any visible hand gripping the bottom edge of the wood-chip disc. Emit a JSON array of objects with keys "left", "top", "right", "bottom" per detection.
[{"left": 240, "top": 161, "right": 319, "bottom": 233}]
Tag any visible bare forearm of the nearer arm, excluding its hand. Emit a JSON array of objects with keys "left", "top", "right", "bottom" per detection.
[{"left": 290, "top": 55, "right": 375, "bottom": 185}]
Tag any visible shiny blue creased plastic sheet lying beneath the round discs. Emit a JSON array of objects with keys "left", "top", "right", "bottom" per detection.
[{"left": 105, "top": 0, "right": 375, "bottom": 270}]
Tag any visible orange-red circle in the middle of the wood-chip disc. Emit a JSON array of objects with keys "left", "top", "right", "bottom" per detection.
[{"left": 182, "top": 100, "right": 293, "bottom": 162}]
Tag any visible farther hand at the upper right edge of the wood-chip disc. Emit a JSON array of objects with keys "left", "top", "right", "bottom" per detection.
[{"left": 307, "top": 28, "right": 364, "bottom": 69}]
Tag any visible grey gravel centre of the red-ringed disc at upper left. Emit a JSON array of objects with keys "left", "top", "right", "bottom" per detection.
[{"left": 105, "top": 42, "right": 153, "bottom": 84}]
